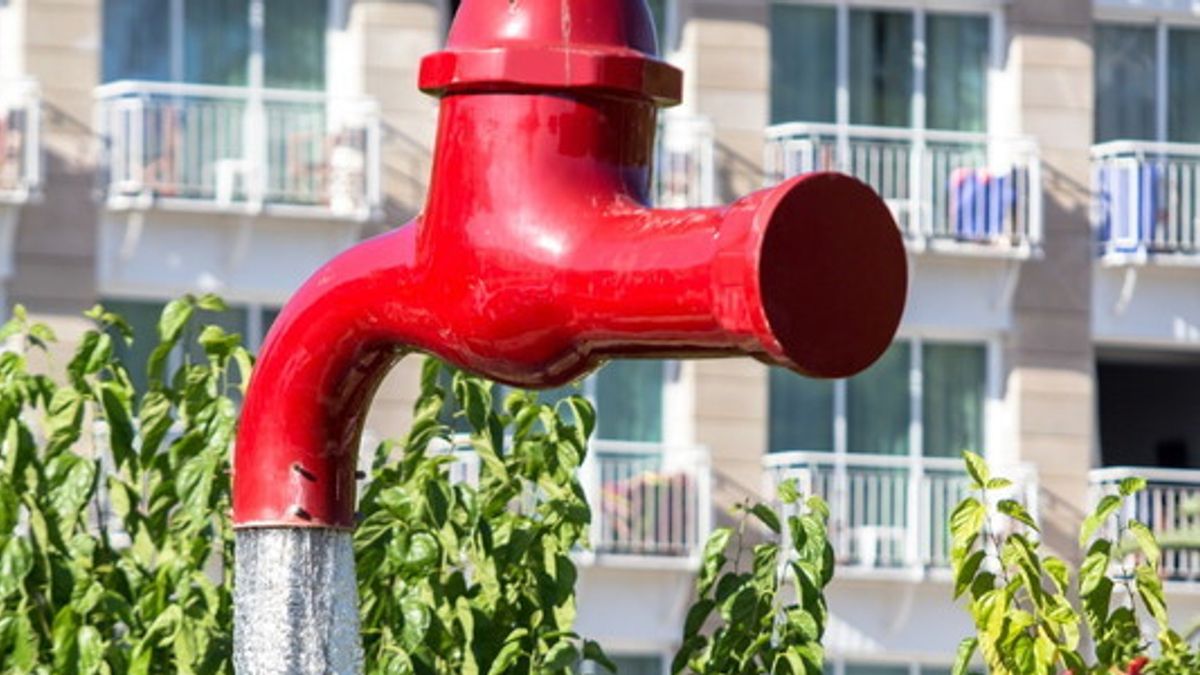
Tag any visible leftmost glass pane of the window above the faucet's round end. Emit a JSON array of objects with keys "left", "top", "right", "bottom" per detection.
[{"left": 770, "top": 4, "right": 838, "bottom": 123}]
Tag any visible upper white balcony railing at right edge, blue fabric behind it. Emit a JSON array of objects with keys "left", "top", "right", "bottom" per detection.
[{"left": 1092, "top": 141, "right": 1200, "bottom": 256}]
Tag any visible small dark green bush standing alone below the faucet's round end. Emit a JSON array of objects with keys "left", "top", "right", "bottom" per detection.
[{"left": 671, "top": 482, "right": 834, "bottom": 675}]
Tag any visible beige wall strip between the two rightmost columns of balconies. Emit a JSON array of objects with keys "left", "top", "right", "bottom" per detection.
[{"left": 1008, "top": 0, "right": 1096, "bottom": 552}]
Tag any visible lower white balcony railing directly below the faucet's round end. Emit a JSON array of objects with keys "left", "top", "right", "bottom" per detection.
[{"left": 763, "top": 452, "right": 1037, "bottom": 569}]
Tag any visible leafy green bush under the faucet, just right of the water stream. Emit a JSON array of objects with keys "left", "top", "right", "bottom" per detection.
[{"left": 355, "top": 360, "right": 612, "bottom": 674}]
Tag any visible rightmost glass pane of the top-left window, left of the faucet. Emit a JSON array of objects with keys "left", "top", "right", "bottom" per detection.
[{"left": 263, "top": 0, "right": 328, "bottom": 90}]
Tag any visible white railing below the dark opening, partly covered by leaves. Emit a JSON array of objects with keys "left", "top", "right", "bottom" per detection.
[{"left": 1088, "top": 466, "right": 1200, "bottom": 580}]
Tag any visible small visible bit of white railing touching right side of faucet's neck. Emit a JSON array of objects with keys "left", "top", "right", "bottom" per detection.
[{"left": 653, "top": 112, "right": 716, "bottom": 208}]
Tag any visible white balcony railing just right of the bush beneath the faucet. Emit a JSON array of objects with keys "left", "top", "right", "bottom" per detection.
[{"left": 449, "top": 441, "right": 713, "bottom": 560}]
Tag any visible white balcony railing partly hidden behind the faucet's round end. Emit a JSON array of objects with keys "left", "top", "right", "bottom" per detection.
[{"left": 766, "top": 123, "right": 1042, "bottom": 255}]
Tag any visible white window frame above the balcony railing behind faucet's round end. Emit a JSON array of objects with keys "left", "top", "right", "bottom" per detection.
[{"left": 768, "top": 0, "right": 1007, "bottom": 133}]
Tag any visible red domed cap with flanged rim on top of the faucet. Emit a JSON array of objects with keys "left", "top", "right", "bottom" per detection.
[{"left": 420, "top": 0, "right": 683, "bottom": 106}]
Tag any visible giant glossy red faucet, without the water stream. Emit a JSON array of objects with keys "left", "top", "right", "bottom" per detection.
[{"left": 234, "top": 0, "right": 907, "bottom": 527}]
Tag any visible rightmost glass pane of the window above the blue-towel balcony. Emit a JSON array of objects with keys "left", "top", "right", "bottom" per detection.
[{"left": 925, "top": 14, "right": 990, "bottom": 131}]
